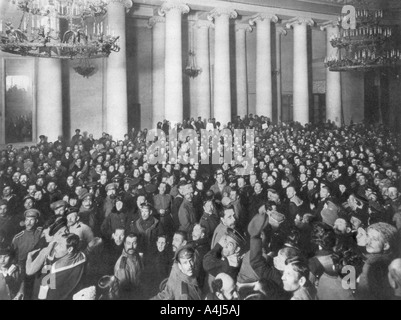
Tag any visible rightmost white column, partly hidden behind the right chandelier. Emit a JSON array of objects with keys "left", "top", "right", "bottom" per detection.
[{"left": 320, "top": 21, "right": 341, "bottom": 126}]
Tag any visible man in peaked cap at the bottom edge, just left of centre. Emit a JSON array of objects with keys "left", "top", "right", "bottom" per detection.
[{"left": 152, "top": 245, "right": 202, "bottom": 300}]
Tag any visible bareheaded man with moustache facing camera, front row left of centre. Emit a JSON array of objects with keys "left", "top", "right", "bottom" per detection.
[{"left": 114, "top": 233, "right": 143, "bottom": 299}]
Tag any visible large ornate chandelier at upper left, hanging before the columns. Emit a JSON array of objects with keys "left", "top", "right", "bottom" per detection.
[{"left": 0, "top": 0, "right": 120, "bottom": 59}]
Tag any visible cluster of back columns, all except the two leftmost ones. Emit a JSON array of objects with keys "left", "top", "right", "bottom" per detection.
[{"left": 150, "top": 2, "right": 341, "bottom": 126}]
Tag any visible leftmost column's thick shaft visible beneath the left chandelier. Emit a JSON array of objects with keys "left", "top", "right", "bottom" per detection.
[{"left": 36, "top": 58, "right": 63, "bottom": 142}]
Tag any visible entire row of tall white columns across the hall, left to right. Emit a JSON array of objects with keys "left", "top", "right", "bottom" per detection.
[{"left": 37, "top": 0, "right": 341, "bottom": 140}]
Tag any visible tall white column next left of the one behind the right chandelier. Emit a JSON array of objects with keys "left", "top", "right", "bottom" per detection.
[{"left": 287, "top": 17, "right": 314, "bottom": 125}]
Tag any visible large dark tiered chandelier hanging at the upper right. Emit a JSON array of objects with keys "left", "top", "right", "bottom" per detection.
[{"left": 325, "top": 0, "right": 400, "bottom": 71}]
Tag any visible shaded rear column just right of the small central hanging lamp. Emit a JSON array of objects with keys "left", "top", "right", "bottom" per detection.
[{"left": 195, "top": 20, "right": 213, "bottom": 120}]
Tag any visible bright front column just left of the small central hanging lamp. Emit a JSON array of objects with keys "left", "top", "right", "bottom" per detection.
[{"left": 159, "top": 1, "right": 189, "bottom": 123}]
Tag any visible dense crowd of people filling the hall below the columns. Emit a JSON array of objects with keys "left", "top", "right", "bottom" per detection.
[{"left": 0, "top": 115, "right": 401, "bottom": 300}]
